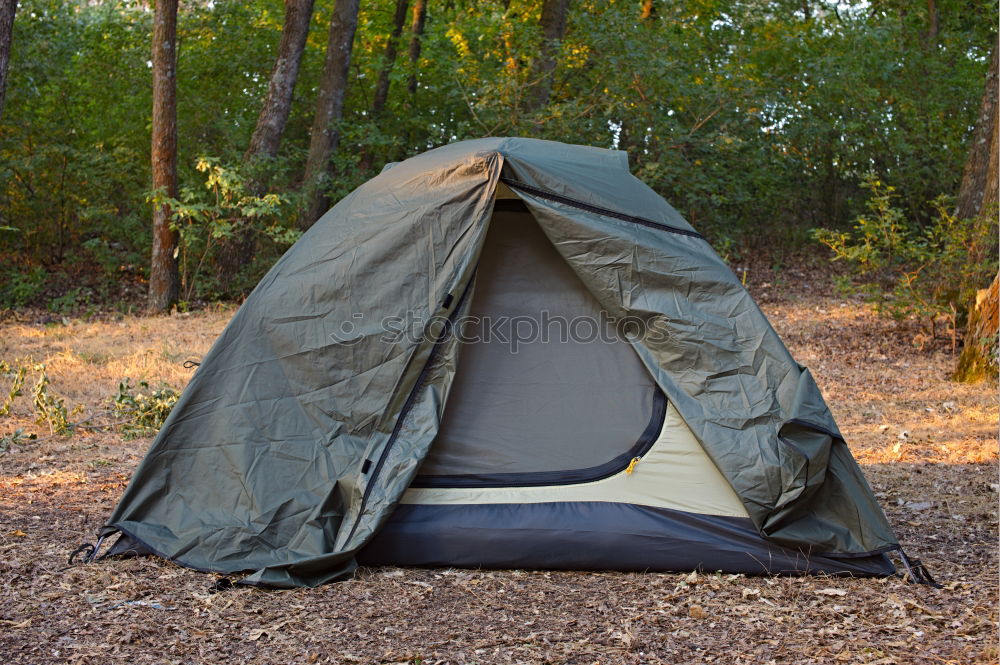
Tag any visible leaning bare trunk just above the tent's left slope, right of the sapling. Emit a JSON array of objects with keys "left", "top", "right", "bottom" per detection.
[{"left": 299, "top": 0, "right": 359, "bottom": 229}]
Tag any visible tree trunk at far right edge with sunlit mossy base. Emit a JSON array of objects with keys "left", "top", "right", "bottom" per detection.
[{"left": 954, "top": 44, "right": 1000, "bottom": 381}]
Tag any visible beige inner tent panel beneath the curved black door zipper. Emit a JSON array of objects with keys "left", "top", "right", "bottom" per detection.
[{"left": 400, "top": 404, "right": 747, "bottom": 517}]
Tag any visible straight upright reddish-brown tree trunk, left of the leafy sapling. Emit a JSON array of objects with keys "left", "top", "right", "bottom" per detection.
[{"left": 148, "top": 0, "right": 180, "bottom": 312}]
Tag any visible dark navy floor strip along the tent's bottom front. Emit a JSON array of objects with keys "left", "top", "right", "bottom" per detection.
[{"left": 358, "top": 501, "right": 895, "bottom": 576}]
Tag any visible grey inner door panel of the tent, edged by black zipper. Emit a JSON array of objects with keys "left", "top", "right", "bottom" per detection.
[{"left": 411, "top": 200, "right": 667, "bottom": 488}]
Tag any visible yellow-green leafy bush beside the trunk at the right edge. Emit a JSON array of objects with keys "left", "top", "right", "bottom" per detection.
[{"left": 813, "top": 174, "right": 998, "bottom": 325}]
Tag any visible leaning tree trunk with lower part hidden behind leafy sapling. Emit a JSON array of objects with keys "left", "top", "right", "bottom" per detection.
[{"left": 215, "top": 0, "right": 314, "bottom": 293}]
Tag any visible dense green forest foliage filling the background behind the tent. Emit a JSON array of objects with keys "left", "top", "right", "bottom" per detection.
[{"left": 0, "top": 0, "right": 997, "bottom": 307}]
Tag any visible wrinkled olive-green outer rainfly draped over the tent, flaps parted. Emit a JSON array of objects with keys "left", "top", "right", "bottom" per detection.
[{"left": 102, "top": 139, "right": 896, "bottom": 587}]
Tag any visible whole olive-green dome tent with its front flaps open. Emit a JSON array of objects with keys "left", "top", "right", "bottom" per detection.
[{"left": 95, "top": 138, "right": 906, "bottom": 587}]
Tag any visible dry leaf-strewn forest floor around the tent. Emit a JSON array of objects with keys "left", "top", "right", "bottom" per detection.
[{"left": 0, "top": 255, "right": 998, "bottom": 665}]
